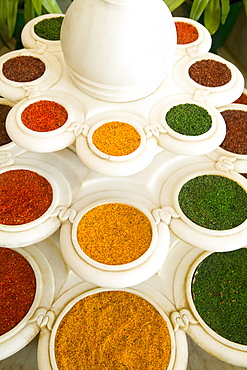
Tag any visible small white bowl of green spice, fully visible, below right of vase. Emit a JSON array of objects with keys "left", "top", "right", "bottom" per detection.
[{"left": 150, "top": 94, "right": 226, "bottom": 155}]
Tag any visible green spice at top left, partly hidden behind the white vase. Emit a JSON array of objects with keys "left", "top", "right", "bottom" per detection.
[{"left": 34, "top": 17, "right": 64, "bottom": 41}]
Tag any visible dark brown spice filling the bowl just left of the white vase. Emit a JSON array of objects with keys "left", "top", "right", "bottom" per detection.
[{"left": 2, "top": 55, "right": 45, "bottom": 82}]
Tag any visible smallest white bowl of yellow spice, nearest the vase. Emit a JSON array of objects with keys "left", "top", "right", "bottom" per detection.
[{"left": 76, "top": 111, "right": 157, "bottom": 176}]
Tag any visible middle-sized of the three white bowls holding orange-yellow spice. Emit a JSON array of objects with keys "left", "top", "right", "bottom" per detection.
[{"left": 60, "top": 193, "right": 170, "bottom": 288}]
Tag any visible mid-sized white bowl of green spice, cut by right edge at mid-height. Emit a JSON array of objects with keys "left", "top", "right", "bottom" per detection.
[{"left": 161, "top": 162, "right": 247, "bottom": 251}]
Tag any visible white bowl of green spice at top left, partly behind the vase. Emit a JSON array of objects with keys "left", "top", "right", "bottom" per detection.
[{"left": 21, "top": 14, "right": 64, "bottom": 52}]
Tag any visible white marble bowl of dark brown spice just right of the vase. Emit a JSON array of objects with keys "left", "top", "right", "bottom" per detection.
[{"left": 173, "top": 53, "right": 244, "bottom": 107}]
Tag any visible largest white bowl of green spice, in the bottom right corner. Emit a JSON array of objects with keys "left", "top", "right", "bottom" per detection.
[{"left": 172, "top": 242, "right": 247, "bottom": 368}]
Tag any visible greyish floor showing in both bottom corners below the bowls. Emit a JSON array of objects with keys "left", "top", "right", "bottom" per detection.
[{"left": 0, "top": 336, "right": 247, "bottom": 370}]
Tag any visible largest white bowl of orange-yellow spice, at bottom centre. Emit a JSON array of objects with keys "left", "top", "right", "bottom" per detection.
[{"left": 38, "top": 282, "right": 188, "bottom": 370}]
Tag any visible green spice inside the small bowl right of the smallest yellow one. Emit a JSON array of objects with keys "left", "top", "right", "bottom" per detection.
[{"left": 165, "top": 103, "right": 212, "bottom": 136}]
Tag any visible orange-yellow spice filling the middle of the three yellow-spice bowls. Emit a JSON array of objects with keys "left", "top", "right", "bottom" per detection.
[{"left": 77, "top": 203, "right": 152, "bottom": 265}]
